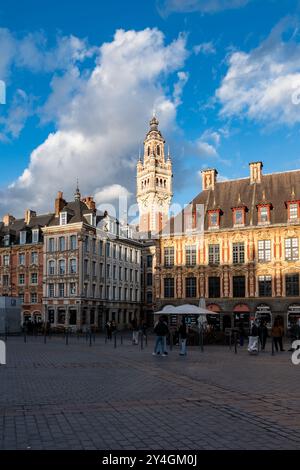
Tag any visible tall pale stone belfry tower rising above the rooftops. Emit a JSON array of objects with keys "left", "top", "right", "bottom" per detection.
[{"left": 137, "top": 116, "right": 173, "bottom": 232}]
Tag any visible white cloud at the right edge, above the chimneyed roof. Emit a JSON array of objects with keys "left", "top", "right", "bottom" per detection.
[{"left": 216, "top": 18, "right": 300, "bottom": 125}]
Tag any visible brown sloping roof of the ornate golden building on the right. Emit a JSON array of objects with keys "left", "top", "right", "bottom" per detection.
[{"left": 162, "top": 170, "right": 300, "bottom": 235}]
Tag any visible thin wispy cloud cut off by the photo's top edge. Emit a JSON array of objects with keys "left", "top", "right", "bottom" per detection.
[{"left": 157, "top": 0, "right": 252, "bottom": 16}]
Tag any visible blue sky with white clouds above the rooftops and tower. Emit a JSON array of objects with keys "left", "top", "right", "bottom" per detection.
[{"left": 0, "top": 0, "right": 300, "bottom": 217}]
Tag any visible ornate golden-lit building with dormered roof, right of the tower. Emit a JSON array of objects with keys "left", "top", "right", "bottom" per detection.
[{"left": 155, "top": 162, "right": 300, "bottom": 329}]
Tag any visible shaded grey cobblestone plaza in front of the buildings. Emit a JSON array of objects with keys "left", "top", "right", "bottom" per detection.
[{"left": 0, "top": 336, "right": 300, "bottom": 450}]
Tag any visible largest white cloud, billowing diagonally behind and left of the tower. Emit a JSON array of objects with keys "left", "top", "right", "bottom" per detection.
[{"left": 0, "top": 28, "right": 187, "bottom": 218}]
